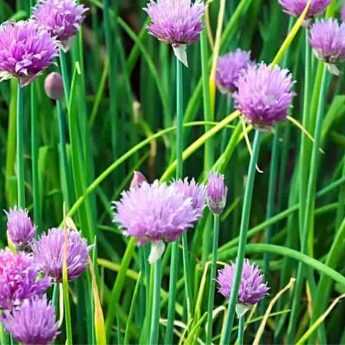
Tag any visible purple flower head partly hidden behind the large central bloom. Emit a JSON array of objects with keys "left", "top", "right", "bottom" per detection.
[{"left": 171, "top": 177, "right": 206, "bottom": 218}]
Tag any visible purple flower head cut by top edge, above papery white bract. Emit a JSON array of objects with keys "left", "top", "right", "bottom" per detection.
[{"left": 144, "top": 0, "right": 205, "bottom": 46}]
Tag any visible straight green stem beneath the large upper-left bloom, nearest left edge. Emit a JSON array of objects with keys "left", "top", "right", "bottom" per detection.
[{"left": 17, "top": 84, "right": 25, "bottom": 208}]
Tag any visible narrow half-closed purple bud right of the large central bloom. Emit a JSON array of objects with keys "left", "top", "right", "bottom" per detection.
[{"left": 206, "top": 173, "right": 228, "bottom": 214}]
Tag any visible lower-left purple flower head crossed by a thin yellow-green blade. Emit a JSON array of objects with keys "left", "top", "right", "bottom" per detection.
[{"left": 32, "top": 228, "right": 89, "bottom": 282}]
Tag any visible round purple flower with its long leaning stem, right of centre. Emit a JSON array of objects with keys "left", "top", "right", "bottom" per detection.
[{"left": 220, "top": 64, "right": 293, "bottom": 345}]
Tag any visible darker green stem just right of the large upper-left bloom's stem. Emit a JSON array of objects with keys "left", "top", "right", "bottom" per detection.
[{"left": 30, "top": 83, "right": 42, "bottom": 230}]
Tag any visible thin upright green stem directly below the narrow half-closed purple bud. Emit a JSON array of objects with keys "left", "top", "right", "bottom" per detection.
[{"left": 206, "top": 214, "right": 219, "bottom": 345}]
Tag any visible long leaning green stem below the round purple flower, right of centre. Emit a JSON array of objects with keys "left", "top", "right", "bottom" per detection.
[{"left": 220, "top": 129, "right": 261, "bottom": 345}]
